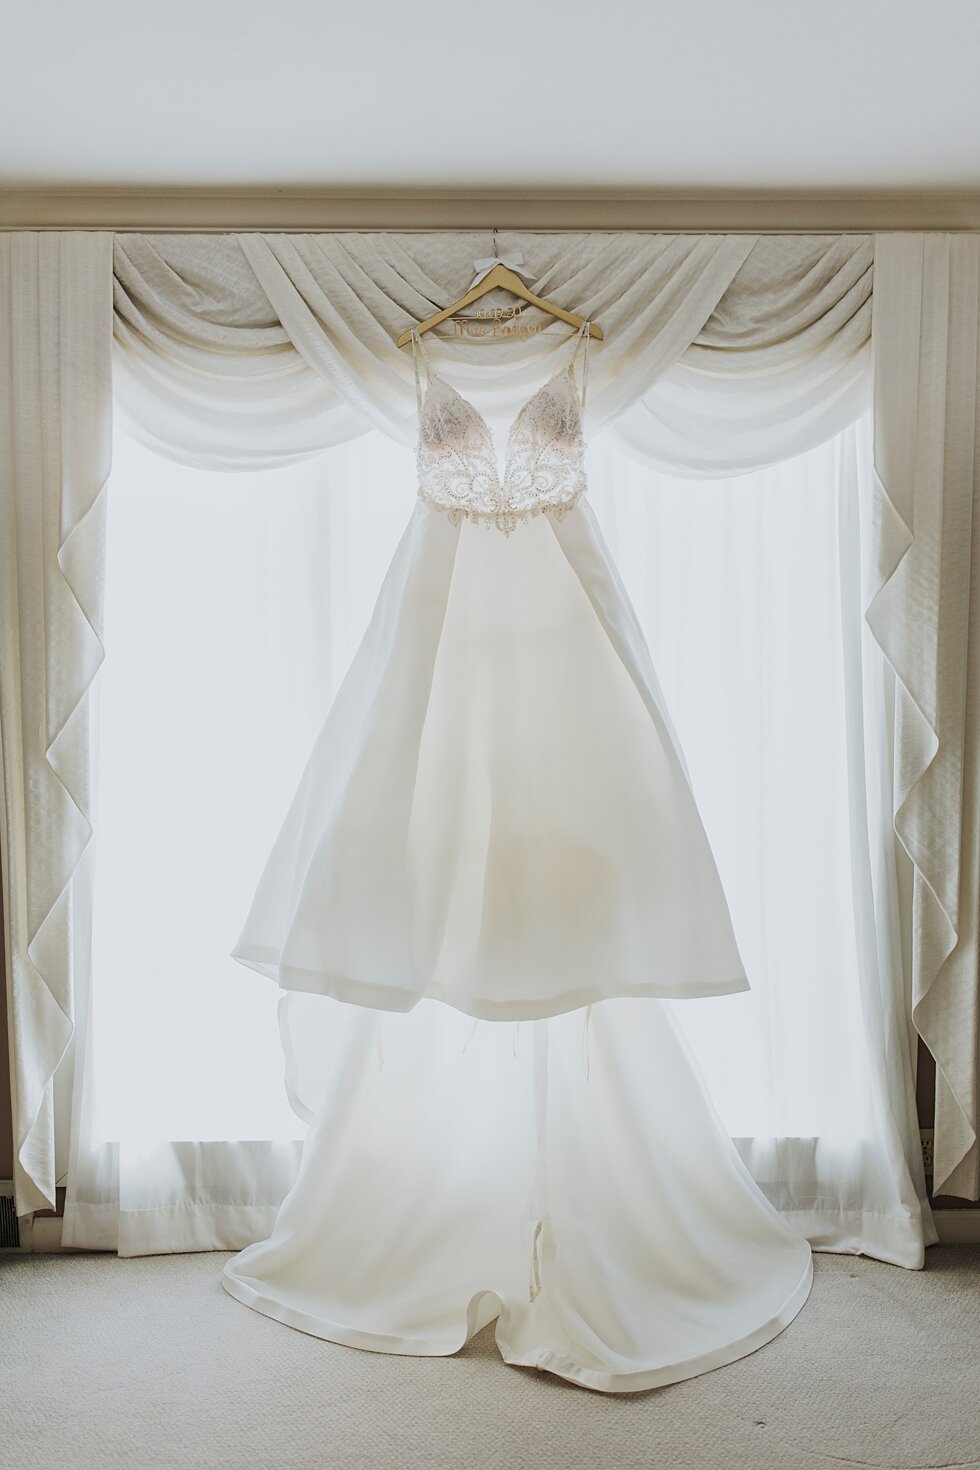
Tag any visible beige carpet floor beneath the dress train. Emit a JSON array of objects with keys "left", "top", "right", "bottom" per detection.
[{"left": 0, "top": 1247, "right": 980, "bottom": 1470}]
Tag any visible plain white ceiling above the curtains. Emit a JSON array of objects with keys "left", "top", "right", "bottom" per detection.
[{"left": 0, "top": 0, "right": 980, "bottom": 191}]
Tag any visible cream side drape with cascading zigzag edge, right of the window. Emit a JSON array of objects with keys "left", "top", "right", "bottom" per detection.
[{"left": 868, "top": 234, "right": 980, "bottom": 1200}]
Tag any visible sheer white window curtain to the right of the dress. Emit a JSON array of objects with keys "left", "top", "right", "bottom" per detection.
[{"left": 592, "top": 416, "right": 936, "bottom": 1264}]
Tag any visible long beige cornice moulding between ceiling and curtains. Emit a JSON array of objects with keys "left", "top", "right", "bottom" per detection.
[{"left": 0, "top": 187, "right": 980, "bottom": 234}]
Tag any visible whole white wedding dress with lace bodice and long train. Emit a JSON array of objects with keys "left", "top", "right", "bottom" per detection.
[{"left": 223, "top": 323, "right": 813, "bottom": 1392}]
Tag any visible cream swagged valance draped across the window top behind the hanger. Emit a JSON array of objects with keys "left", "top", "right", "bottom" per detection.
[{"left": 115, "top": 232, "right": 873, "bottom": 473}]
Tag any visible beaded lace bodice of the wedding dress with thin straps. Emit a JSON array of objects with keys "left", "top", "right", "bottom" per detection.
[{"left": 411, "top": 322, "right": 589, "bottom": 535}]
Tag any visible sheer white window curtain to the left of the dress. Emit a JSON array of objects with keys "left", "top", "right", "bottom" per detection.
[{"left": 65, "top": 431, "right": 413, "bottom": 1254}]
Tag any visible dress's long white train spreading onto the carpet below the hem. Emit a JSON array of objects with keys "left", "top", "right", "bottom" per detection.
[{"left": 222, "top": 995, "right": 813, "bottom": 1394}]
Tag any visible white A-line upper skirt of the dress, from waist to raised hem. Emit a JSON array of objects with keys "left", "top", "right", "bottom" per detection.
[{"left": 234, "top": 501, "right": 748, "bottom": 1020}]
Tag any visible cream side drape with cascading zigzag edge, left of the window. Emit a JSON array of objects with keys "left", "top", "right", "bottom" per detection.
[{"left": 0, "top": 232, "right": 112, "bottom": 1214}]
